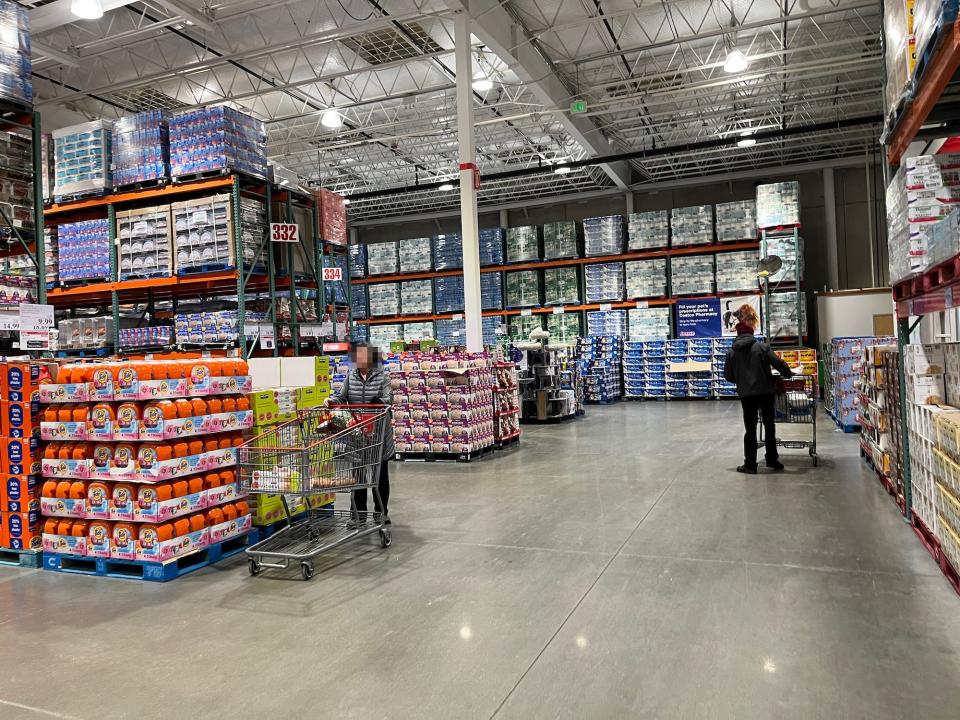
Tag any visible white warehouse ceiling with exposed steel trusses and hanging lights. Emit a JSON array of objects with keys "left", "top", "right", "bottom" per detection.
[{"left": 23, "top": 0, "right": 883, "bottom": 220}]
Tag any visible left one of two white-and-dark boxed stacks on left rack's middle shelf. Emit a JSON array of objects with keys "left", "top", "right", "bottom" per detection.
[{"left": 116, "top": 205, "right": 173, "bottom": 280}]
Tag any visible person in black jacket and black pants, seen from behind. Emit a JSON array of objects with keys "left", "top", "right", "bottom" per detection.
[{"left": 723, "top": 320, "right": 793, "bottom": 475}]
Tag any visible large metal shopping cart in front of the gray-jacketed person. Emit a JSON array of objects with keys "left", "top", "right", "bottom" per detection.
[{"left": 238, "top": 405, "right": 392, "bottom": 580}]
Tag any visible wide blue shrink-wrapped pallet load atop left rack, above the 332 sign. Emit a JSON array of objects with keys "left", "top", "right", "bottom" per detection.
[{"left": 170, "top": 105, "right": 266, "bottom": 180}]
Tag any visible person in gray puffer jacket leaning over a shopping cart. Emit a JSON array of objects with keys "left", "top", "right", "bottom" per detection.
[{"left": 327, "top": 343, "right": 395, "bottom": 525}]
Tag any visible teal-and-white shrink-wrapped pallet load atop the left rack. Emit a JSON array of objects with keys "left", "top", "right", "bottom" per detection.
[{"left": 53, "top": 120, "right": 113, "bottom": 198}]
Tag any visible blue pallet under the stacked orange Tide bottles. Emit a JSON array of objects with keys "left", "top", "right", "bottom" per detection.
[{"left": 43, "top": 534, "right": 249, "bottom": 582}]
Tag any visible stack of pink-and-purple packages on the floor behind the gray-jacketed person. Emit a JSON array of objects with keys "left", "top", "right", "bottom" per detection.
[{"left": 385, "top": 352, "right": 495, "bottom": 459}]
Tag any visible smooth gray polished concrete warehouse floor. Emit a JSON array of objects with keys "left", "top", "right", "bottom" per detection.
[{"left": 0, "top": 402, "right": 960, "bottom": 720}]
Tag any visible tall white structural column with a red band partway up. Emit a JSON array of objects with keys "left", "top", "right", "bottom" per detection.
[{"left": 453, "top": 12, "right": 483, "bottom": 352}]
